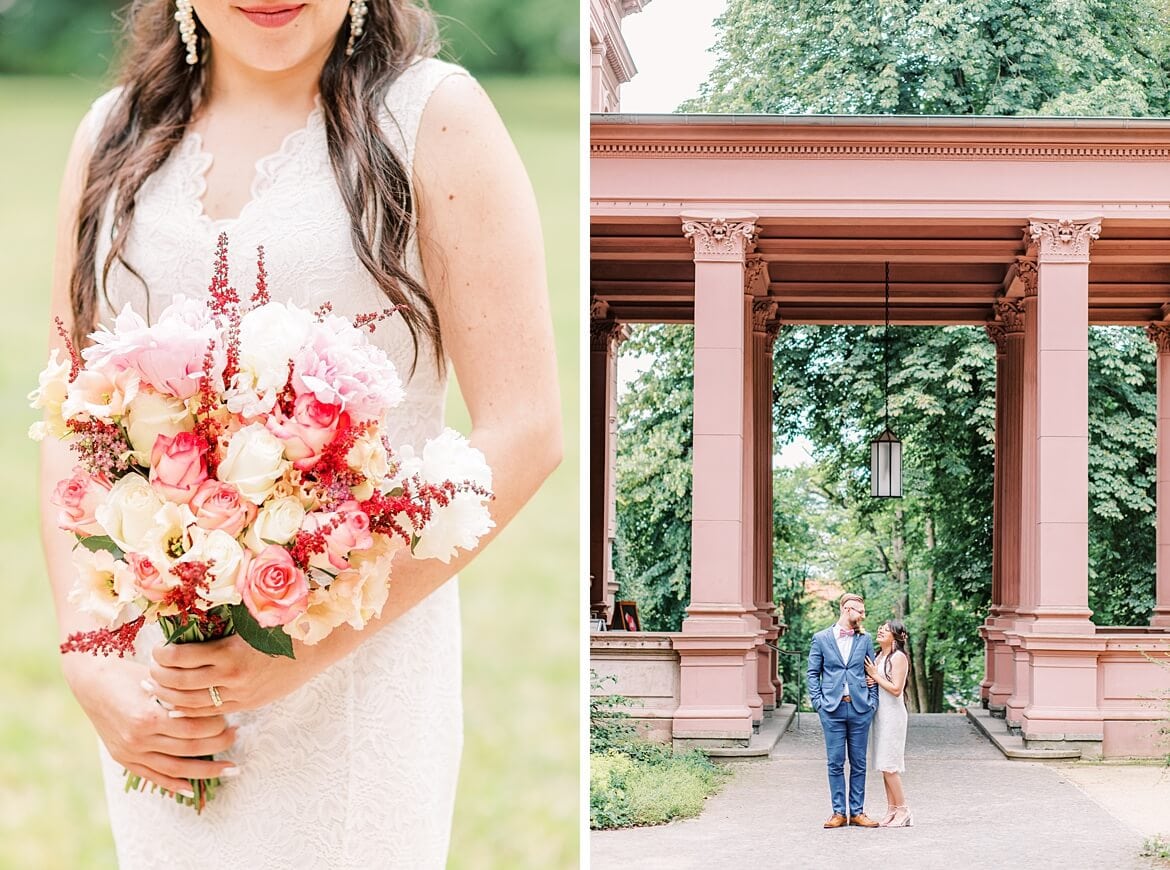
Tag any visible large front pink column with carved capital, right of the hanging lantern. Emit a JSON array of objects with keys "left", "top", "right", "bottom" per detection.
[{"left": 1019, "top": 220, "right": 1102, "bottom": 755}]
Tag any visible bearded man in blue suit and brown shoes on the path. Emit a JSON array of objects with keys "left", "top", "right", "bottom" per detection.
[{"left": 808, "top": 593, "right": 878, "bottom": 828}]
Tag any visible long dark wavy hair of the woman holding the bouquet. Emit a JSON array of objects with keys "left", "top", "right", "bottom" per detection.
[{"left": 69, "top": 0, "right": 442, "bottom": 367}]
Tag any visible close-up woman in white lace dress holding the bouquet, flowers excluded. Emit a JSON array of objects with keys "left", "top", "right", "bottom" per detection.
[{"left": 42, "top": 0, "right": 560, "bottom": 870}]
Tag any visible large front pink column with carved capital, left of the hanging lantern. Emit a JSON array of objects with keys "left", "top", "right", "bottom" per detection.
[{"left": 673, "top": 214, "right": 759, "bottom": 745}]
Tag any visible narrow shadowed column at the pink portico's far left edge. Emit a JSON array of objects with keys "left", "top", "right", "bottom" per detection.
[{"left": 589, "top": 301, "right": 625, "bottom": 621}]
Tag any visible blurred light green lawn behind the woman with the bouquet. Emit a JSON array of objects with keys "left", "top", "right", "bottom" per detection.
[{"left": 0, "top": 78, "right": 581, "bottom": 870}]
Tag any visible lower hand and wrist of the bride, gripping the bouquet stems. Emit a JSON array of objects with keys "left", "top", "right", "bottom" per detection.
[{"left": 64, "top": 655, "right": 235, "bottom": 795}]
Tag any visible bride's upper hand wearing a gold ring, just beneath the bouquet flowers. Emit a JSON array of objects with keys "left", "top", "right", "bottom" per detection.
[{"left": 150, "top": 635, "right": 316, "bottom": 717}]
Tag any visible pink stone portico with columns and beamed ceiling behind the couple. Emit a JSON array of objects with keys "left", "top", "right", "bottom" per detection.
[{"left": 590, "top": 2, "right": 1170, "bottom": 758}]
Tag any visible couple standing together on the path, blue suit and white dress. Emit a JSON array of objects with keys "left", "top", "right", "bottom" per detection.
[{"left": 808, "top": 593, "right": 913, "bottom": 828}]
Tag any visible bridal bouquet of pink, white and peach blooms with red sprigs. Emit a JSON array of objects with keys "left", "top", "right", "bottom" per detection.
[{"left": 29, "top": 235, "right": 493, "bottom": 809}]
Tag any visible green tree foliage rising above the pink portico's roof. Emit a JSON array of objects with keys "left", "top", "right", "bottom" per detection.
[{"left": 682, "top": 0, "right": 1170, "bottom": 117}]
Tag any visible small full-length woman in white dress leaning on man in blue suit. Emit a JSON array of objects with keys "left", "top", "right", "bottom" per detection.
[{"left": 866, "top": 620, "right": 914, "bottom": 828}]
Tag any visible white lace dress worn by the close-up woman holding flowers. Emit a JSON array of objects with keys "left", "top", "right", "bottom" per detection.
[{"left": 90, "top": 60, "right": 467, "bottom": 870}]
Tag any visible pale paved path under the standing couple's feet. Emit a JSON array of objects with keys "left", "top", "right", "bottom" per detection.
[{"left": 590, "top": 713, "right": 1170, "bottom": 870}]
